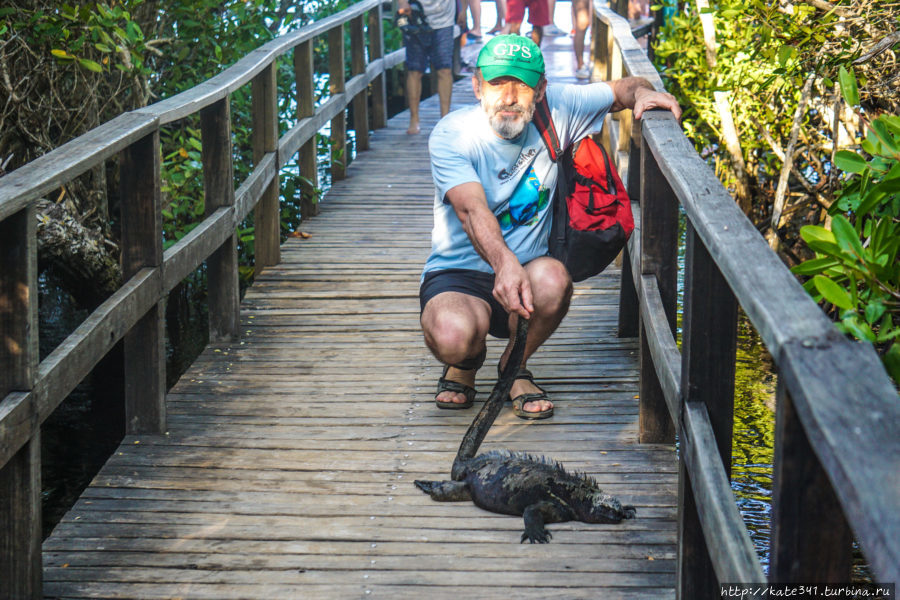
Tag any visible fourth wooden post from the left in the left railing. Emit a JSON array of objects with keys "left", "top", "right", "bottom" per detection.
[{"left": 252, "top": 61, "right": 281, "bottom": 270}]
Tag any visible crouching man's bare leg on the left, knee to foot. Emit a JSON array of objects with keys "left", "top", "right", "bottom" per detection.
[{"left": 421, "top": 292, "right": 491, "bottom": 404}]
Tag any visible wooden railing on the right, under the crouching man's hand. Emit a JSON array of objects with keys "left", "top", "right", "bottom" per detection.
[{"left": 592, "top": 3, "right": 900, "bottom": 600}]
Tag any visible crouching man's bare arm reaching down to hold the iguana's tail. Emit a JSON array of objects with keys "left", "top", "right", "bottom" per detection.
[{"left": 446, "top": 182, "right": 534, "bottom": 319}]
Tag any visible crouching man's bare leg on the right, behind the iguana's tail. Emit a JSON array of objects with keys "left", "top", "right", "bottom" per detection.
[{"left": 500, "top": 257, "right": 572, "bottom": 412}]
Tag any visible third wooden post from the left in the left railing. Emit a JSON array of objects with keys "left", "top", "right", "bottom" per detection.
[{"left": 200, "top": 96, "right": 240, "bottom": 342}]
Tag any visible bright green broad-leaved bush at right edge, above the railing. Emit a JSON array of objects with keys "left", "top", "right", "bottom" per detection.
[{"left": 792, "top": 111, "right": 900, "bottom": 383}]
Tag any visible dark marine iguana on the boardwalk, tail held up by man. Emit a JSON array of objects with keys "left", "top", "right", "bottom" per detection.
[{"left": 414, "top": 319, "right": 635, "bottom": 544}]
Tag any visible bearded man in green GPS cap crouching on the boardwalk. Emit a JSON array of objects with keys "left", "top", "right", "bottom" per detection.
[{"left": 419, "top": 35, "right": 681, "bottom": 419}]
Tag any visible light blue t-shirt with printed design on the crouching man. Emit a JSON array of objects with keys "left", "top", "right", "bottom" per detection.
[{"left": 423, "top": 82, "right": 614, "bottom": 277}]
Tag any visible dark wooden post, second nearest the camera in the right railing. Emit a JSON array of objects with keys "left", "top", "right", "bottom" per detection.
[{"left": 677, "top": 222, "right": 737, "bottom": 599}]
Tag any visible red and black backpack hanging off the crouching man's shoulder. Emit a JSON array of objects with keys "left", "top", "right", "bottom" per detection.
[{"left": 534, "top": 97, "right": 634, "bottom": 281}]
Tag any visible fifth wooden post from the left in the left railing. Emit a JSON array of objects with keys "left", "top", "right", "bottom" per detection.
[{"left": 294, "top": 40, "right": 319, "bottom": 219}]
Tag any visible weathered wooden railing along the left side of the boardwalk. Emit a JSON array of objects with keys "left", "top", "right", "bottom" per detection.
[{"left": 0, "top": 0, "right": 405, "bottom": 598}]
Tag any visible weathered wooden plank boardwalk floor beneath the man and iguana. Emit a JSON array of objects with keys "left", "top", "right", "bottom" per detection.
[{"left": 44, "top": 34, "right": 677, "bottom": 600}]
